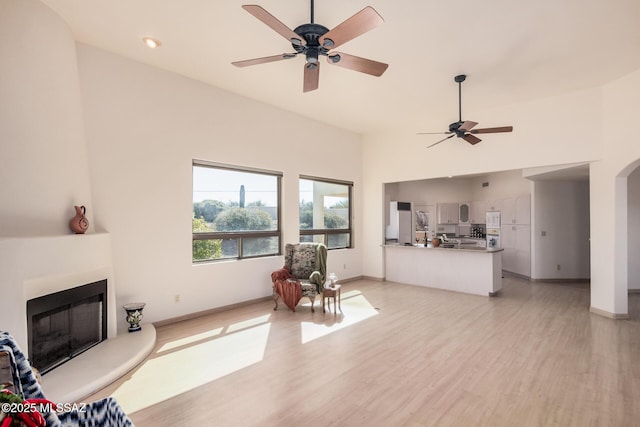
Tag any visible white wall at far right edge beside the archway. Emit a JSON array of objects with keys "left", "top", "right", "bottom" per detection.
[{"left": 590, "top": 70, "right": 640, "bottom": 314}]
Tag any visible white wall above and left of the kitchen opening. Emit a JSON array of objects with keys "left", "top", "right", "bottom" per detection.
[{"left": 363, "top": 88, "right": 602, "bottom": 277}]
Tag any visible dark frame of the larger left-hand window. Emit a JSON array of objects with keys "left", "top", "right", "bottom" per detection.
[{"left": 191, "top": 159, "right": 283, "bottom": 264}]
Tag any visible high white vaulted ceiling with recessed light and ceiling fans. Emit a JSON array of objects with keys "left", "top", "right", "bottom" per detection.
[{"left": 42, "top": 0, "right": 640, "bottom": 133}]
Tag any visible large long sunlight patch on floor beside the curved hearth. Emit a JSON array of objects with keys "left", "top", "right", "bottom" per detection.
[{"left": 112, "top": 317, "right": 271, "bottom": 414}]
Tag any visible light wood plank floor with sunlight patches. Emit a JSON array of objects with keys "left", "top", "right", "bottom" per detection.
[{"left": 82, "top": 277, "right": 640, "bottom": 427}]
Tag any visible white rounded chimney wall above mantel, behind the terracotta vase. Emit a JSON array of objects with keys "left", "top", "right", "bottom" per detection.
[{"left": 0, "top": 0, "right": 95, "bottom": 236}]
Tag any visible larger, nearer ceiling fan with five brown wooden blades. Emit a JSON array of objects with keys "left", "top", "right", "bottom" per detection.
[{"left": 232, "top": 0, "right": 389, "bottom": 92}]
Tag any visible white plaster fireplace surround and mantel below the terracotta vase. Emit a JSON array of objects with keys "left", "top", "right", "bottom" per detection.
[{"left": 0, "top": 233, "right": 117, "bottom": 354}]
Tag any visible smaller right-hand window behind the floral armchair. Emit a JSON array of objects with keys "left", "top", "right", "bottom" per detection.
[{"left": 300, "top": 176, "right": 353, "bottom": 249}]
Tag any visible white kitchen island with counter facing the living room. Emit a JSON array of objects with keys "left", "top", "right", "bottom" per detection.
[{"left": 384, "top": 245, "right": 503, "bottom": 296}]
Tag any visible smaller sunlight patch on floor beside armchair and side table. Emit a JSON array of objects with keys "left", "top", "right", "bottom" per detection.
[{"left": 300, "top": 290, "right": 378, "bottom": 344}]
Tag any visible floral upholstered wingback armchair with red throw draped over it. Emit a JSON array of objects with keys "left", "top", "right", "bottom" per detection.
[{"left": 271, "top": 243, "right": 327, "bottom": 312}]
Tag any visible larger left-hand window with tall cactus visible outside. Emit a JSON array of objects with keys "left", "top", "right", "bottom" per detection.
[{"left": 192, "top": 161, "right": 282, "bottom": 262}]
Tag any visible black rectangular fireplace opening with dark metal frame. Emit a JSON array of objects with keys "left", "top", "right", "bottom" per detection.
[{"left": 27, "top": 279, "right": 107, "bottom": 374}]
